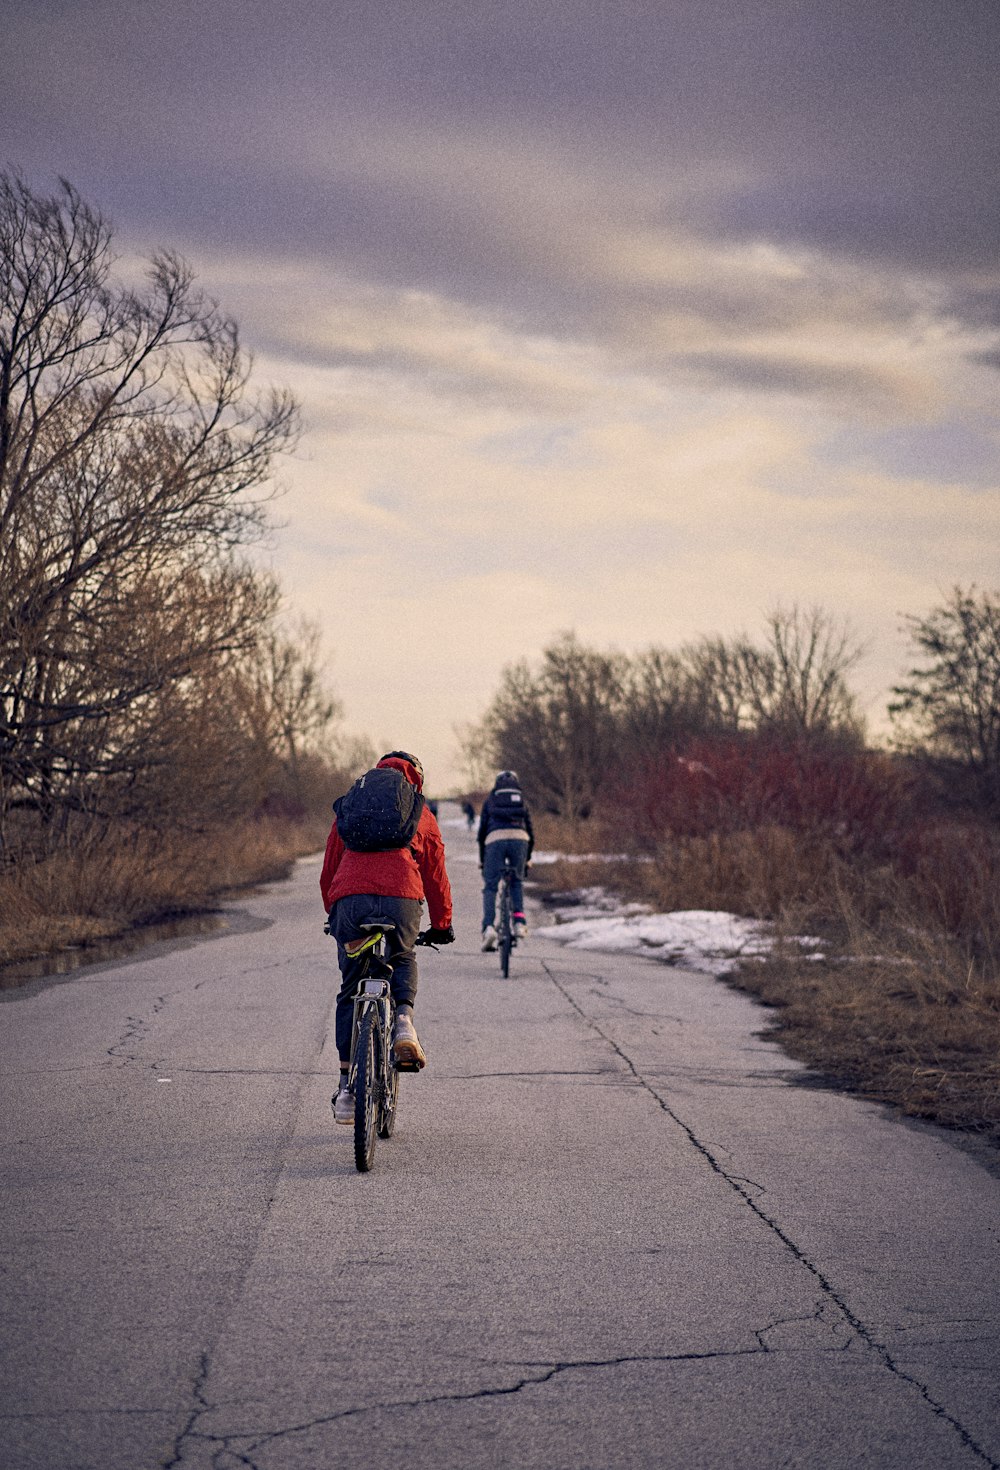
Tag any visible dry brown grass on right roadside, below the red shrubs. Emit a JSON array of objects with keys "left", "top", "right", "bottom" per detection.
[{"left": 532, "top": 826, "right": 1000, "bottom": 1142}]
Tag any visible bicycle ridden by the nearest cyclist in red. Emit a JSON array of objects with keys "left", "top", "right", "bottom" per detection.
[{"left": 344, "top": 920, "right": 437, "bottom": 1173}]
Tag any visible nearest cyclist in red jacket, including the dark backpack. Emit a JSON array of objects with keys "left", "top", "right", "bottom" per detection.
[{"left": 319, "top": 750, "right": 454, "bottom": 1123}]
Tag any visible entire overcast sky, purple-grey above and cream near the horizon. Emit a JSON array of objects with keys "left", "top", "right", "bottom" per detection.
[{"left": 0, "top": 0, "right": 1000, "bottom": 788}]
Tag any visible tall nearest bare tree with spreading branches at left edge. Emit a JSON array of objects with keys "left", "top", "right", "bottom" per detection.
[{"left": 0, "top": 172, "right": 296, "bottom": 835}]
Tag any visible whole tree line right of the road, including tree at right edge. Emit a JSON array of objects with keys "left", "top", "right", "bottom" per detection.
[{"left": 463, "top": 587, "right": 1000, "bottom": 823}]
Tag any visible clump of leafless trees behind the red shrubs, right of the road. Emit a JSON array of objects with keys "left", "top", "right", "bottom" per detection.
[{"left": 473, "top": 607, "right": 862, "bottom": 823}]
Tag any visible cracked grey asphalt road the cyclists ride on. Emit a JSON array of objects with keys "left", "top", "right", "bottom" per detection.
[{"left": 0, "top": 810, "right": 1000, "bottom": 1470}]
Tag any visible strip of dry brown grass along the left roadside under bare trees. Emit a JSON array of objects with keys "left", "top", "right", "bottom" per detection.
[{"left": 0, "top": 820, "right": 325, "bottom": 966}]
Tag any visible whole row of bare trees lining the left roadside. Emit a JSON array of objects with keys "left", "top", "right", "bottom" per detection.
[{"left": 0, "top": 171, "right": 337, "bottom": 857}]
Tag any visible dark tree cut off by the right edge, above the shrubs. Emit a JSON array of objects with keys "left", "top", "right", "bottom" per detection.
[{"left": 890, "top": 587, "right": 1000, "bottom": 806}]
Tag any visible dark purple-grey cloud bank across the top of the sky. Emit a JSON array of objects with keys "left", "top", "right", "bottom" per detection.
[{"left": 7, "top": 0, "right": 1000, "bottom": 279}]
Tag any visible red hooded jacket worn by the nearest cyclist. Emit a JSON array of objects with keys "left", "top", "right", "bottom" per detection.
[{"left": 319, "top": 756, "right": 451, "bottom": 929}]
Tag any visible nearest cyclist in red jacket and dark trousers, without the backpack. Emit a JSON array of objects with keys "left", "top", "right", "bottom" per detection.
[{"left": 319, "top": 750, "right": 454, "bottom": 1123}]
